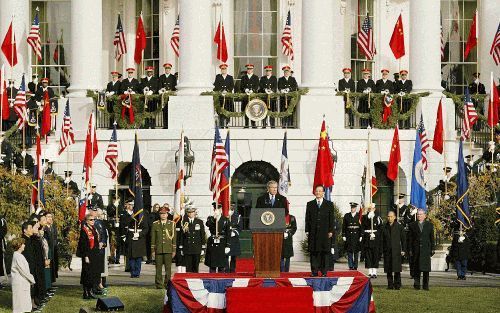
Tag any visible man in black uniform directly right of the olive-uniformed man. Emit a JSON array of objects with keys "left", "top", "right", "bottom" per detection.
[{"left": 181, "top": 208, "right": 206, "bottom": 273}]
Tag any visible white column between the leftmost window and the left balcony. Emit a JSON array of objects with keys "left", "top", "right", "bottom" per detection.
[{"left": 69, "top": 0, "right": 103, "bottom": 97}]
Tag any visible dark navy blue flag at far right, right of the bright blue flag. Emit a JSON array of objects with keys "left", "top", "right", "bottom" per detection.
[{"left": 456, "top": 140, "right": 471, "bottom": 229}]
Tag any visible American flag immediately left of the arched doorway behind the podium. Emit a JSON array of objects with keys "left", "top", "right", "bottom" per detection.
[{"left": 210, "top": 127, "right": 229, "bottom": 202}]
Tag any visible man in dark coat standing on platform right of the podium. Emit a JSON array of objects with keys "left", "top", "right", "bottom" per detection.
[{"left": 305, "top": 185, "right": 335, "bottom": 277}]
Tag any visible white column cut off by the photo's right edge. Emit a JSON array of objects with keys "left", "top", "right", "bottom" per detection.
[{"left": 479, "top": 0, "right": 500, "bottom": 93}]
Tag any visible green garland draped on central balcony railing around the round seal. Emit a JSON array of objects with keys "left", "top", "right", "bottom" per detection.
[{"left": 201, "top": 88, "right": 308, "bottom": 118}]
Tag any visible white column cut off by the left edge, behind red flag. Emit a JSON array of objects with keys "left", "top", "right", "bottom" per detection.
[{"left": 0, "top": 0, "right": 31, "bottom": 86}]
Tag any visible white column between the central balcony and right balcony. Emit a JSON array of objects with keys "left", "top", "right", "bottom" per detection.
[{"left": 302, "top": 0, "right": 336, "bottom": 95}]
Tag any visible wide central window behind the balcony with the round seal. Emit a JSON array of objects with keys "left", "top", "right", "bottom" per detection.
[{"left": 234, "top": 0, "right": 278, "bottom": 77}]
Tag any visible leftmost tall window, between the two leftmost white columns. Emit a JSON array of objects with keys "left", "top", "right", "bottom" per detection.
[{"left": 30, "top": 1, "right": 71, "bottom": 94}]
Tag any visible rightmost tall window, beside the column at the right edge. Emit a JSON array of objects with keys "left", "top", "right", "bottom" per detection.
[{"left": 441, "top": 0, "right": 478, "bottom": 94}]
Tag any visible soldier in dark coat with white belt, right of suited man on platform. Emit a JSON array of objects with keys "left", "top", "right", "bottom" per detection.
[{"left": 361, "top": 203, "right": 382, "bottom": 278}]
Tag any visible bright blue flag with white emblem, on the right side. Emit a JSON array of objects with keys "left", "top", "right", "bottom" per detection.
[{"left": 410, "top": 130, "right": 427, "bottom": 212}]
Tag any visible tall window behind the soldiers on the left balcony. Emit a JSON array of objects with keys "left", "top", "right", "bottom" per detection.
[{"left": 137, "top": 0, "right": 160, "bottom": 76}]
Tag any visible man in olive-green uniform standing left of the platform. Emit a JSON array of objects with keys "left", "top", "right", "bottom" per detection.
[{"left": 151, "top": 207, "right": 176, "bottom": 289}]
